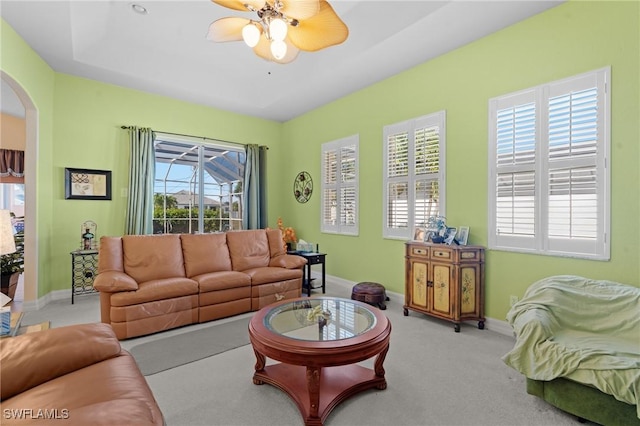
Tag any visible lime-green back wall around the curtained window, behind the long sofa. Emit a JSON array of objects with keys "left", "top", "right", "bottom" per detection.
[{"left": 52, "top": 74, "right": 282, "bottom": 296}]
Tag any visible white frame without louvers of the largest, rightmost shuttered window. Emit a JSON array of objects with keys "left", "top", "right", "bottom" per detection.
[{"left": 488, "top": 67, "right": 611, "bottom": 260}]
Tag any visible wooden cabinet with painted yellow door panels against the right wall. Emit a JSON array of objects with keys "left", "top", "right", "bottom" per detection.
[{"left": 404, "top": 241, "right": 485, "bottom": 332}]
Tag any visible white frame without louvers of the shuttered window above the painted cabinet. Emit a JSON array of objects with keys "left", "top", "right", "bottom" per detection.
[{"left": 382, "top": 110, "right": 446, "bottom": 240}]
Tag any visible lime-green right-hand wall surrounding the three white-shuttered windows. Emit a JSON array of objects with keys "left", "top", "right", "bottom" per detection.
[{"left": 278, "top": 2, "right": 640, "bottom": 319}]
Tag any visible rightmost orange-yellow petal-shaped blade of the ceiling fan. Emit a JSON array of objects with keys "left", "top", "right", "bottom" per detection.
[{"left": 287, "top": 0, "right": 349, "bottom": 52}]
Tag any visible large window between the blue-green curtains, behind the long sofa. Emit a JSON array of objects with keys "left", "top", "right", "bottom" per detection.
[{"left": 153, "top": 133, "right": 246, "bottom": 234}]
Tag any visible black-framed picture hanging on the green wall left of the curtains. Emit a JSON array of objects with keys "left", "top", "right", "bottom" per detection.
[{"left": 64, "top": 168, "right": 111, "bottom": 200}]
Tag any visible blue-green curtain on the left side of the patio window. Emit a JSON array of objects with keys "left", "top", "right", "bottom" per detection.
[{"left": 125, "top": 126, "right": 156, "bottom": 235}]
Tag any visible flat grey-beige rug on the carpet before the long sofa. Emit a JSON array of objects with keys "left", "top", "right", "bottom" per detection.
[{"left": 129, "top": 318, "right": 251, "bottom": 376}]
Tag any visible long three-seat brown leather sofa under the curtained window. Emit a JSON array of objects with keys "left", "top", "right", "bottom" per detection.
[{"left": 93, "top": 229, "right": 306, "bottom": 339}]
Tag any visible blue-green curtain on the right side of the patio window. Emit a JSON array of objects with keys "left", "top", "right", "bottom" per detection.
[{"left": 242, "top": 145, "right": 268, "bottom": 229}]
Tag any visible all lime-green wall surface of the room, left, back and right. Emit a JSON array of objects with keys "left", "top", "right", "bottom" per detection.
[{"left": 0, "top": 1, "right": 640, "bottom": 319}]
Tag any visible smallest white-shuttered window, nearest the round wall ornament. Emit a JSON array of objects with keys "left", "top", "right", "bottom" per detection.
[{"left": 320, "top": 135, "right": 359, "bottom": 235}]
